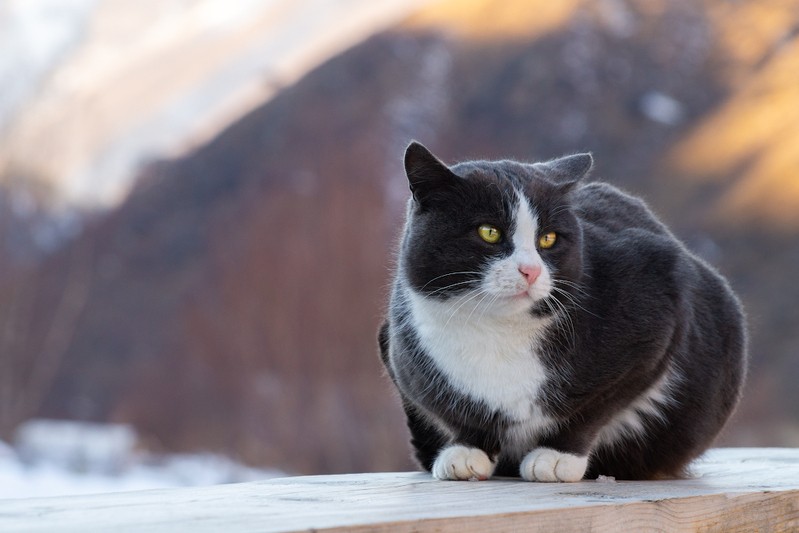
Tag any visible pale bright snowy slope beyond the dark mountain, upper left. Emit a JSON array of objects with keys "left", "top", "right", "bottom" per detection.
[{"left": 0, "top": 0, "right": 421, "bottom": 259}]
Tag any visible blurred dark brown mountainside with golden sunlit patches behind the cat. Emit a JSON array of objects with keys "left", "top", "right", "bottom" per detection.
[{"left": 0, "top": 0, "right": 799, "bottom": 472}]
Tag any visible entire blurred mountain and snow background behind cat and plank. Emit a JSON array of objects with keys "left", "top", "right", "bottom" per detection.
[{"left": 0, "top": 0, "right": 799, "bottom": 497}]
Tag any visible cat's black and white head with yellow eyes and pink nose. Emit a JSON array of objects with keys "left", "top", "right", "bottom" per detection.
[{"left": 400, "top": 142, "right": 593, "bottom": 315}]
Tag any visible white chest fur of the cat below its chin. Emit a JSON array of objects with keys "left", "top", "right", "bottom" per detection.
[{"left": 410, "top": 288, "right": 548, "bottom": 429}]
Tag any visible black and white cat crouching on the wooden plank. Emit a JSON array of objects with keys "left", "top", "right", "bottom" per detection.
[{"left": 379, "top": 142, "right": 747, "bottom": 482}]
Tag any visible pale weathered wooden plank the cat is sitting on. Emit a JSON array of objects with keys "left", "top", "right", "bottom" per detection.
[{"left": 0, "top": 448, "right": 799, "bottom": 533}]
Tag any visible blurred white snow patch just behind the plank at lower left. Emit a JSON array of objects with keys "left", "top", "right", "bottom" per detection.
[{"left": 0, "top": 420, "right": 285, "bottom": 499}]
